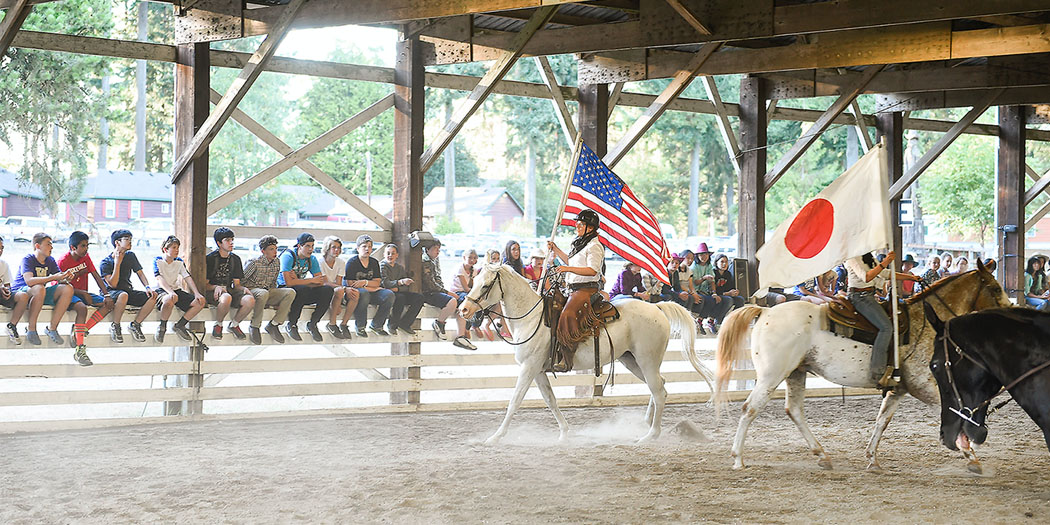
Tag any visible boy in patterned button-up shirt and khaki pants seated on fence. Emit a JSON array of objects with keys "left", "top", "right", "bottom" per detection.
[{"left": 242, "top": 235, "right": 295, "bottom": 344}]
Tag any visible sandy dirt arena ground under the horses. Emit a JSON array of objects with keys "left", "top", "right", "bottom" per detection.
[{"left": 0, "top": 397, "right": 1050, "bottom": 524}]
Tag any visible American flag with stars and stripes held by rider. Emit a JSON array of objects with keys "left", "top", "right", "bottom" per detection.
[{"left": 562, "top": 143, "right": 671, "bottom": 285}]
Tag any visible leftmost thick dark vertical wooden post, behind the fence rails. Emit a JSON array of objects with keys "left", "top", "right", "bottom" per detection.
[{"left": 171, "top": 43, "right": 211, "bottom": 415}]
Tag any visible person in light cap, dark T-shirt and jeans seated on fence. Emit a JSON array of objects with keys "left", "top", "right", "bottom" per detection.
[{"left": 344, "top": 234, "right": 394, "bottom": 337}]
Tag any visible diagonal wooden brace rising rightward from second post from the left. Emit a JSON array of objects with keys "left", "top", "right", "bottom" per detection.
[{"left": 420, "top": 5, "right": 558, "bottom": 173}]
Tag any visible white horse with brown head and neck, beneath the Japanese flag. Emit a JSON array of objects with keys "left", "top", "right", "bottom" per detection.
[{"left": 714, "top": 261, "right": 1010, "bottom": 469}]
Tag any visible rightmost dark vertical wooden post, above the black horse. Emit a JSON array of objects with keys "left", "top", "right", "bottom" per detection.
[{"left": 995, "top": 106, "right": 1025, "bottom": 305}]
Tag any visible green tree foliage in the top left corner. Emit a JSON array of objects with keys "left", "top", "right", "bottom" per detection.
[{"left": 0, "top": 0, "right": 112, "bottom": 213}]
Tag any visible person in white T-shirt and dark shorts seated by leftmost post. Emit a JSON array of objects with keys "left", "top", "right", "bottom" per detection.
[{"left": 153, "top": 235, "right": 207, "bottom": 342}]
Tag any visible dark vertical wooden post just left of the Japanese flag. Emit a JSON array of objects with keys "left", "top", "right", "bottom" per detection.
[{"left": 736, "top": 77, "right": 770, "bottom": 295}]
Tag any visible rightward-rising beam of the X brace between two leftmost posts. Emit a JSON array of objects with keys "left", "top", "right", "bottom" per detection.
[{"left": 208, "top": 93, "right": 394, "bottom": 216}]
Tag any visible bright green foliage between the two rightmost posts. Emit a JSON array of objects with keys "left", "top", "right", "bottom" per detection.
[{"left": 919, "top": 135, "right": 995, "bottom": 249}]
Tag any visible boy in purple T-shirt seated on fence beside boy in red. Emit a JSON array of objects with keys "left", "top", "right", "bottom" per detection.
[{"left": 12, "top": 233, "right": 80, "bottom": 352}]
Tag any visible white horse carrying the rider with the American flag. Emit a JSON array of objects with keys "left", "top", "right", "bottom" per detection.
[{"left": 460, "top": 264, "right": 713, "bottom": 444}]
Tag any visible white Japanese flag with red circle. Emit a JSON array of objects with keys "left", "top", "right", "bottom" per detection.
[{"left": 756, "top": 144, "right": 890, "bottom": 288}]
